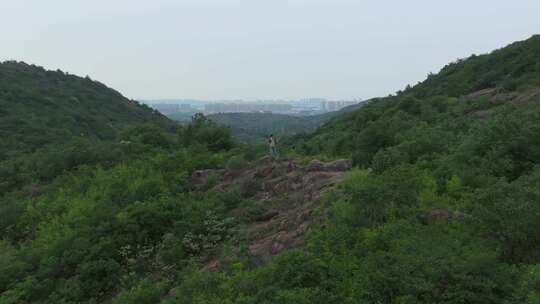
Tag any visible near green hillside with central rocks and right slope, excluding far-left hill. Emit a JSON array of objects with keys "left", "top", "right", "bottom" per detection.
[{"left": 0, "top": 36, "right": 540, "bottom": 304}]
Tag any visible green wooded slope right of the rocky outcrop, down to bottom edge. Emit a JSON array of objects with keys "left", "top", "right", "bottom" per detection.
[{"left": 166, "top": 36, "right": 540, "bottom": 304}]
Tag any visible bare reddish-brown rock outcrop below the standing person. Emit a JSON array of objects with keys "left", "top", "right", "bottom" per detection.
[{"left": 192, "top": 157, "right": 352, "bottom": 262}]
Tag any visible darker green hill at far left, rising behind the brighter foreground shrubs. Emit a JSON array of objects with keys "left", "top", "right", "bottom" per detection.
[{"left": 0, "top": 61, "right": 172, "bottom": 158}]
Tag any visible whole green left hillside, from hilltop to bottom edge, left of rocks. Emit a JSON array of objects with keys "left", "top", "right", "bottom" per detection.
[{"left": 0, "top": 69, "right": 242, "bottom": 303}]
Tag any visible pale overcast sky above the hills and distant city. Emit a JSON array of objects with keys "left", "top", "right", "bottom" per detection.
[{"left": 0, "top": 0, "right": 540, "bottom": 99}]
